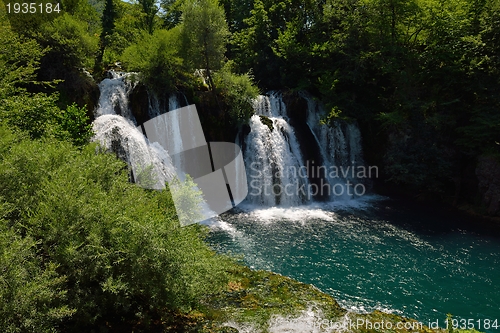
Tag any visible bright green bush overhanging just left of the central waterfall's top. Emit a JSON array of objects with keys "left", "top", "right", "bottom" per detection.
[{"left": 214, "top": 62, "right": 259, "bottom": 124}]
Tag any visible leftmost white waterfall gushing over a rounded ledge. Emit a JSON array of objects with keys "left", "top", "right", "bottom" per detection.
[{"left": 93, "top": 71, "right": 175, "bottom": 189}]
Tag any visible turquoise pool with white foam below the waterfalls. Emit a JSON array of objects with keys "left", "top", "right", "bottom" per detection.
[{"left": 209, "top": 199, "right": 500, "bottom": 331}]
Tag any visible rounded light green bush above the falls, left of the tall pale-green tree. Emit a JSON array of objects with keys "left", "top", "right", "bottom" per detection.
[{"left": 123, "top": 29, "right": 182, "bottom": 94}]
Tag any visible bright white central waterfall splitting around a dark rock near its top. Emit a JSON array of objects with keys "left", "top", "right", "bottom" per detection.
[{"left": 244, "top": 93, "right": 311, "bottom": 207}]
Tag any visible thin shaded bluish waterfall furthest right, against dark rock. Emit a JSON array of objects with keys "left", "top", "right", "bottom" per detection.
[{"left": 302, "top": 94, "right": 365, "bottom": 200}]
